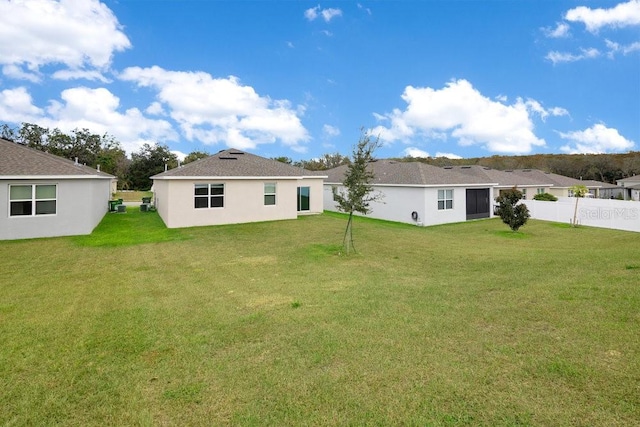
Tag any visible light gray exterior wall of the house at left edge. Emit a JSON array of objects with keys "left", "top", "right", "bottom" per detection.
[{"left": 0, "top": 179, "right": 111, "bottom": 240}]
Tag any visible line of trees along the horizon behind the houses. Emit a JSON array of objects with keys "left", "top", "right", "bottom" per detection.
[{"left": 0, "top": 123, "right": 640, "bottom": 190}]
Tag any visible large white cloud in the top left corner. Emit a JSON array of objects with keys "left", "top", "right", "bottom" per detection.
[{"left": 0, "top": 0, "right": 131, "bottom": 79}]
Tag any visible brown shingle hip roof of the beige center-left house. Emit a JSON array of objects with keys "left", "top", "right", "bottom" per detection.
[{"left": 151, "top": 148, "right": 326, "bottom": 179}]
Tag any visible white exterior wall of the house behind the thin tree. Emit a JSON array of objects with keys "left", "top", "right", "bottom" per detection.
[{"left": 324, "top": 184, "right": 467, "bottom": 226}]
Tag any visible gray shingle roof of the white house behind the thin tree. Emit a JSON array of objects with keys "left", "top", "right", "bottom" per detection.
[{"left": 325, "top": 160, "right": 497, "bottom": 185}]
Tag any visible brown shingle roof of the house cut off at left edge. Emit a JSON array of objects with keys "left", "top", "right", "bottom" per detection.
[{"left": 0, "top": 138, "right": 115, "bottom": 178}]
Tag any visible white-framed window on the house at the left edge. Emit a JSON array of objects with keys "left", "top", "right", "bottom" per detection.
[{"left": 9, "top": 184, "right": 57, "bottom": 216}]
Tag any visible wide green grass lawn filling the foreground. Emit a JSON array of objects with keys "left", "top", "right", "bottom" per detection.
[{"left": 0, "top": 216, "right": 640, "bottom": 426}]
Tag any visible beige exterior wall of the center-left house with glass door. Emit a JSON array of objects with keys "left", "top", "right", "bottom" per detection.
[{"left": 154, "top": 179, "right": 312, "bottom": 228}]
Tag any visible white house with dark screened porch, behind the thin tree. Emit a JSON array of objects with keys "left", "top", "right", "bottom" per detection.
[{"left": 324, "top": 160, "right": 498, "bottom": 226}]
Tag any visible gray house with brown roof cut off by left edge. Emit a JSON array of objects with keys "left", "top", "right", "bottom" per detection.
[{"left": 0, "top": 138, "right": 114, "bottom": 240}]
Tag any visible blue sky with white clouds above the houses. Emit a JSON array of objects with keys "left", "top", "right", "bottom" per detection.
[{"left": 0, "top": 0, "right": 640, "bottom": 160}]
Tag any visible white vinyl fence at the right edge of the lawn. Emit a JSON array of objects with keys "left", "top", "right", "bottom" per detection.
[{"left": 523, "top": 197, "right": 640, "bottom": 232}]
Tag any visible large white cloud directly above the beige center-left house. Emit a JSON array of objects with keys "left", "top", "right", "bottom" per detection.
[{"left": 120, "top": 66, "right": 309, "bottom": 152}]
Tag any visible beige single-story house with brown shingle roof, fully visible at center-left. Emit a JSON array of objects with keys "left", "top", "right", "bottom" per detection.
[{"left": 151, "top": 149, "right": 326, "bottom": 228}]
